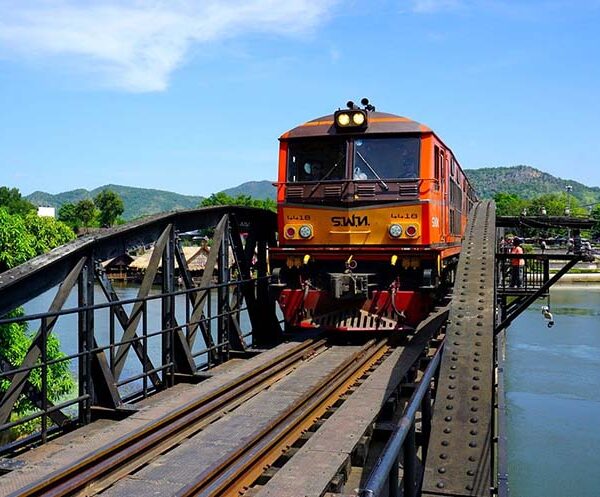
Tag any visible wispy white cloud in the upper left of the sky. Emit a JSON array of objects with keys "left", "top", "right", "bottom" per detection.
[{"left": 0, "top": 0, "right": 337, "bottom": 92}]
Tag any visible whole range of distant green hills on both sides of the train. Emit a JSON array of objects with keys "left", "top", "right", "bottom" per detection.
[{"left": 26, "top": 166, "right": 600, "bottom": 220}]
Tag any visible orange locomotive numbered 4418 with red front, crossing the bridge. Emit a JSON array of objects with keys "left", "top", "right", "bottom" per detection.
[{"left": 270, "top": 99, "right": 476, "bottom": 331}]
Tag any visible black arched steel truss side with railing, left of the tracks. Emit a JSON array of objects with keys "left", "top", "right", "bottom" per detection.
[{"left": 0, "top": 207, "right": 281, "bottom": 452}]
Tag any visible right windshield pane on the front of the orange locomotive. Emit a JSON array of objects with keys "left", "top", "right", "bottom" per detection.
[{"left": 353, "top": 137, "right": 420, "bottom": 180}]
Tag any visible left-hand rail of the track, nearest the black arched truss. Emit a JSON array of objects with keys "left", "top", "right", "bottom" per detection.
[{"left": 9, "top": 339, "right": 327, "bottom": 497}]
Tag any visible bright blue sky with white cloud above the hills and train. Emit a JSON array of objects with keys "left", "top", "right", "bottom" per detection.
[{"left": 0, "top": 0, "right": 600, "bottom": 195}]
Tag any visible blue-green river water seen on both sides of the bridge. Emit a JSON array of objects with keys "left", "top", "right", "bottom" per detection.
[{"left": 25, "top": 286, "right": 600, "bottom": 497}]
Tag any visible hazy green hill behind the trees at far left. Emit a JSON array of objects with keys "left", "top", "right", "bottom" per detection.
[{"left": 26, "top": 185, "right": 202, "bottom": 221}]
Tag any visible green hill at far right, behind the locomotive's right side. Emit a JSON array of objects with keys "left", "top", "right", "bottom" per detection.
[{"left": 465, "top": 166, "right": 600, "bottom": 205}]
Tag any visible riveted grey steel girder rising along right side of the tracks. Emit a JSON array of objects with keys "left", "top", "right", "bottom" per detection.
[{"left": 422, "top": 202, "right": 495, "bottom": 497}]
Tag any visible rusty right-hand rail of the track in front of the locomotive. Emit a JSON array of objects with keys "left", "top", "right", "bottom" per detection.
[{"left": 175, "top": 340, "right": 390, "bottom": 497}]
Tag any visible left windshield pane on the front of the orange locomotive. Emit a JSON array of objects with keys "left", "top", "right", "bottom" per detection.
[{"left": 288, "top": 139, "right": 346, "bottom": 182}]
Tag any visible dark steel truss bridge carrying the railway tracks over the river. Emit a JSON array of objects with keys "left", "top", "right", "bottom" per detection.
[{"left": 0, "top": 202, "right": 585, "bottom": 497}]
